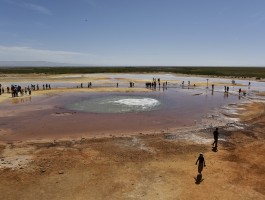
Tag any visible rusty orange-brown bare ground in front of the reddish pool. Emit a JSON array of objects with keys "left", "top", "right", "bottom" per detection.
[{"left": 0, "top": 73, "right": 265, "bottom": 200}]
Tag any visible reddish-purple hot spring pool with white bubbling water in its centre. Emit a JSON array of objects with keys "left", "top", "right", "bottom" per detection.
[{"left": 0, "top": 88, "right": 239, "bottom": 140}]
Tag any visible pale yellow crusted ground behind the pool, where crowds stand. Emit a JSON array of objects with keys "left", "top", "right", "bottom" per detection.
[{"left": 0, "top": 73, "right": 248, "bottom": 103}]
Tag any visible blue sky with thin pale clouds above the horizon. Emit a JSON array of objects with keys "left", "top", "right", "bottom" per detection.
[{"left": 0, "top": 0, "right": 265, "bottom": 66}]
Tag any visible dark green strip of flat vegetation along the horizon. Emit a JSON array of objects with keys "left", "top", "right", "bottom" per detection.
[{"left": 0, "top": 67, "right": 265, "bottom": 79}]
